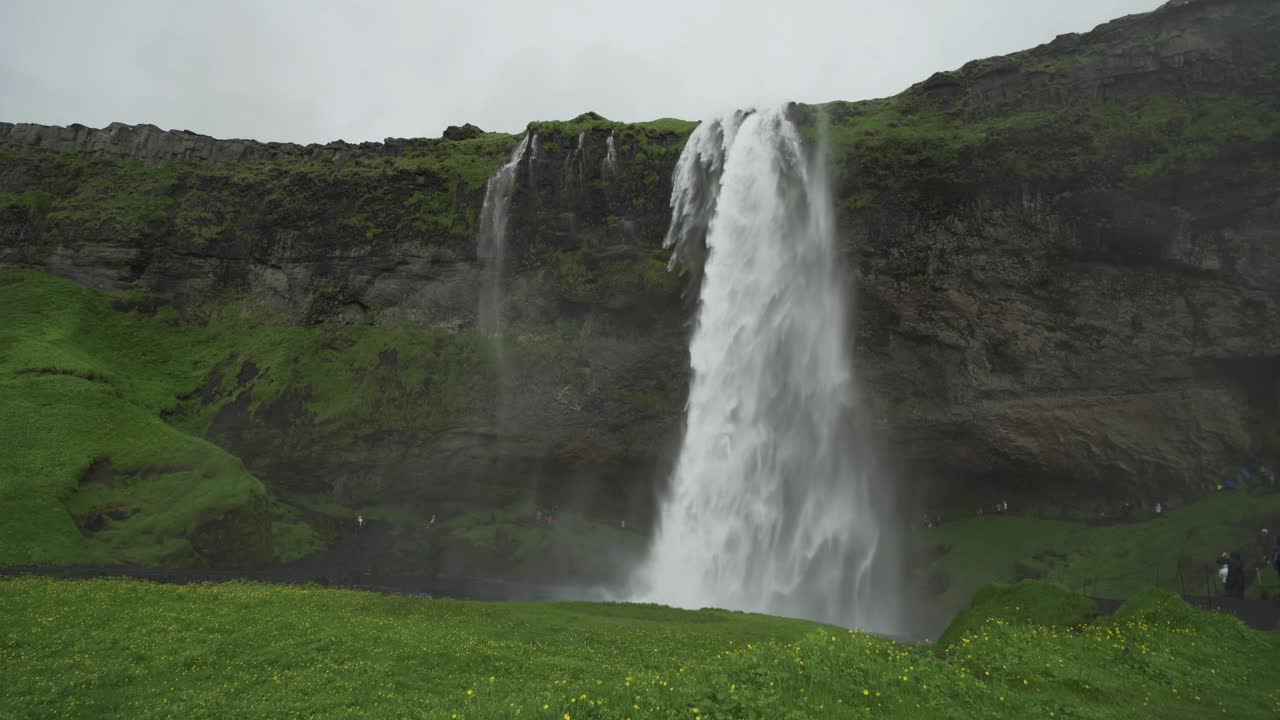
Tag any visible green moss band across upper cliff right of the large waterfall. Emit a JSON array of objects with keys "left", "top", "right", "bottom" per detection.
[{"left": 809, "top": 95, "right": 1280, "bottom": 211}]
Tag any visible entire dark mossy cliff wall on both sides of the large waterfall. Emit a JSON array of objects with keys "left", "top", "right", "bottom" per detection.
[{"left": 0, "top": 0, "right": 1280, "bottom": 506}]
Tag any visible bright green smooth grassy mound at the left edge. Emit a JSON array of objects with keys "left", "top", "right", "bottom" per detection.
[{"left": 0, "top": 269, "right": 264, "bottom": 565}]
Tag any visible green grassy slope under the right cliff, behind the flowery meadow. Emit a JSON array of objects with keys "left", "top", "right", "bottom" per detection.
[{"left": 913, "top": 493, "right": 1280, "bottom": 607}]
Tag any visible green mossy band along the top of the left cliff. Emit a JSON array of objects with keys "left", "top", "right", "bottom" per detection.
[{"left": 0, "top": 128, "right": 517, "bottom": 252}]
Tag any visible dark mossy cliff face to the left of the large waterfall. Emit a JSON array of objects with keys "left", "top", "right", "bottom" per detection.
[{"left": 0, "top": 114, "right": 692, "bottom": 517}]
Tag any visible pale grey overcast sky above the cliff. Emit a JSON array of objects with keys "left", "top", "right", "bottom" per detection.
[{"left": 0, "top": 0, "right": 1161, "bottom": 142}]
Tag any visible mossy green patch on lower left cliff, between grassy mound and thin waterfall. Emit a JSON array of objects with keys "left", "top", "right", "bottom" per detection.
[{"left": 174, "top": 304, "right": 494, "bottom": 454}]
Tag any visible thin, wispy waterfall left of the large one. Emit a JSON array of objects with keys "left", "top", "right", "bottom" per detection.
[{"left": 476, "top": 135, "right": 536, "bottom": 424}]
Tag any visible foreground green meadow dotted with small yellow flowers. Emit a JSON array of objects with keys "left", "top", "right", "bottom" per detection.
[{"left": 0, "top": 578, "right": 1280, "bottom": 720}]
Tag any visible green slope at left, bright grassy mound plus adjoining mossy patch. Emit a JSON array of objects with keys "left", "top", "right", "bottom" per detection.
[{"left": 0, "top": 268, "right": 504, "bottom": 566}]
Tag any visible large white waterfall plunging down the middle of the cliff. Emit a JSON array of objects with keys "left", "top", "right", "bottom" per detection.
[{"left": 632, "top": 105, "right": 899, "bottom": 632}]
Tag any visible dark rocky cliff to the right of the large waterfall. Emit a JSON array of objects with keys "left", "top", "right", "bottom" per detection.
[{"left": 837, "top": 0, "right": 1280, "bottom": 506}]
